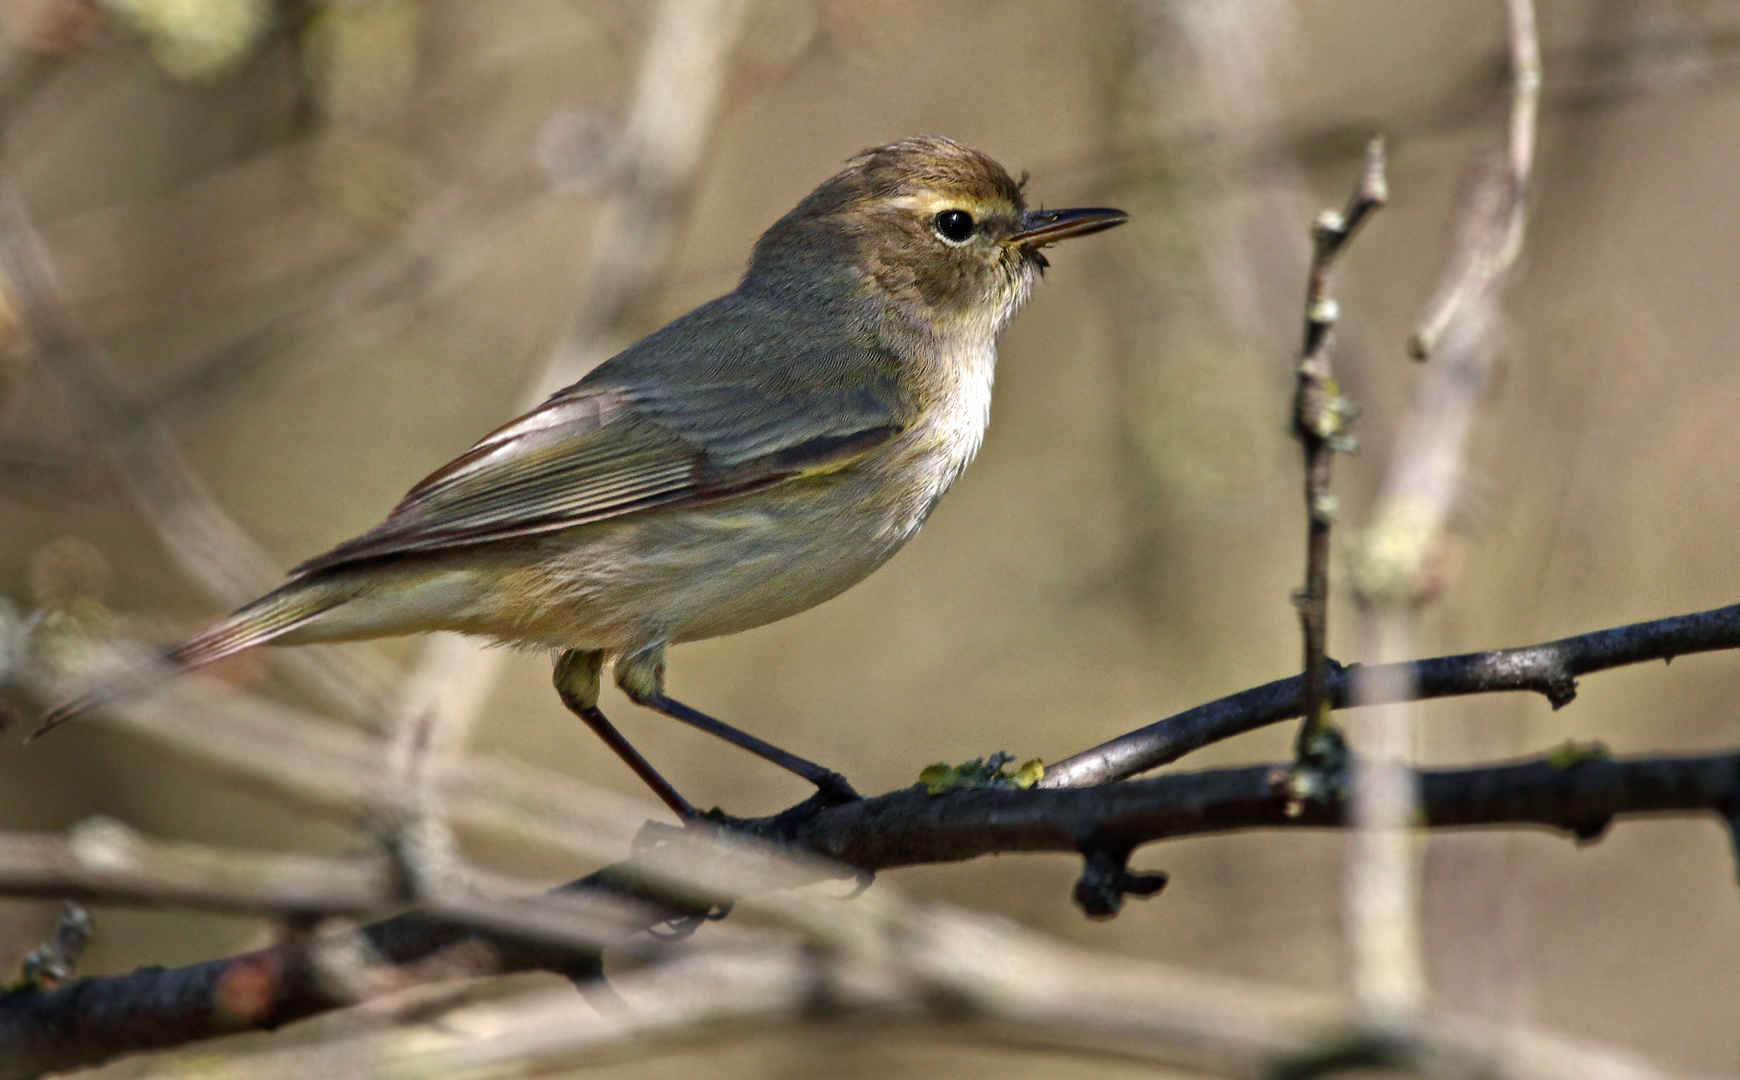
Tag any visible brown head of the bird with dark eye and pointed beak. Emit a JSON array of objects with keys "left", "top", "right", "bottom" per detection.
[{"left": 745, "top": 136, "right": 1126, "bottom": 334}]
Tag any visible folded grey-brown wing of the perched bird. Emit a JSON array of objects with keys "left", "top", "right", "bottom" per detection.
[{"left": 294, "top": 297, "right": 903, "bottom": 574}]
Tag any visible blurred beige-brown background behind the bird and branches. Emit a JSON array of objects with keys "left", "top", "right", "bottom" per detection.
[{"left": 0, "top": 0, "right": 1740, "bottom": 1077}]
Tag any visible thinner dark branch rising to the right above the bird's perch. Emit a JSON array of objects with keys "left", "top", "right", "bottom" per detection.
[{"left": 1039, "top": 603, "right": 1740, "bottom": 788}]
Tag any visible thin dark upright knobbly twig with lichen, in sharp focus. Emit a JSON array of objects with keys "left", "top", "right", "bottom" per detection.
[{"left": 1293, "top": 137, "right": 1389, "bottom": 767}]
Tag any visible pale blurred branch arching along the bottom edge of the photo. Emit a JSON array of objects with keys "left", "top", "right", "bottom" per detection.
[{"left": 74, "top": 932, "right": 1705, "bottom": 1080}]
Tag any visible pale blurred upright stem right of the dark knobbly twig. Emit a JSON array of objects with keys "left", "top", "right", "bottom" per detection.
[{"left": 1345, "top": 0, "right": 1540, "bottom": 1030}]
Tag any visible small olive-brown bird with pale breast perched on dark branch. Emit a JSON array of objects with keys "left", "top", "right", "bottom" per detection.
[{"left": 42, "top": 136, "right": 1128, "bottom": 817}]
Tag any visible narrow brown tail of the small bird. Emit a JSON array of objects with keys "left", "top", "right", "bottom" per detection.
[{"left": 30, "top": 577, "right": 353, "bottom": 739}]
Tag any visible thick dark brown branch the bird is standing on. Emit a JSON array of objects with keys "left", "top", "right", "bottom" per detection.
[{"left": 0, "top": 740, "right": 1740, "bottom": 1080}]
